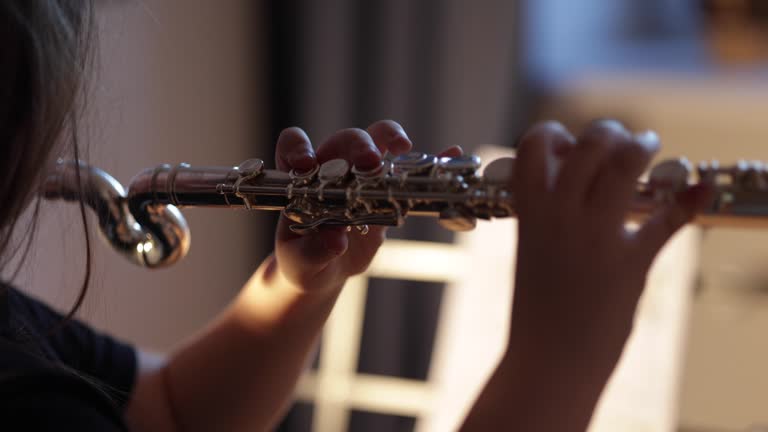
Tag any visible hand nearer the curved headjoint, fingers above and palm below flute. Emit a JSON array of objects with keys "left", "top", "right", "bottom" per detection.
[{"left": 275, "top": 120, "right": 461, "bottom": 290}]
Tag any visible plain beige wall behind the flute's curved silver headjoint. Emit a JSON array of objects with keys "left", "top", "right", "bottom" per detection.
[{"left": 11, "top": 0, "right": 271, "bottom": 348}]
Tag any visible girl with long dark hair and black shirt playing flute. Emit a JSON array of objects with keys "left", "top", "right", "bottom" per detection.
[{"left": 0, "top": 0, "right": 706, "bottom": 431}]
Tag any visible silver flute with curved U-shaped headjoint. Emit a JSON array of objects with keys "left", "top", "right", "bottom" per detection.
[{"left": 42, "top": 152, "right": 768, "bottom": 268}]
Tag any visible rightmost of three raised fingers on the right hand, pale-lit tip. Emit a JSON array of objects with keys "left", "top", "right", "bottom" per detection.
[{"left": 587, "top": 131, "right": 659, "bottom": 223}]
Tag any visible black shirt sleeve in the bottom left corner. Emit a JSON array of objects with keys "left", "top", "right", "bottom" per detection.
[{"left": 0, "top": 284, "right": 136, "bottom": 432}]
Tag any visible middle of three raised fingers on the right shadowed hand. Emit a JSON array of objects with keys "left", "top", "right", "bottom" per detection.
[{"left": 555, "top": 120, "right": 632, "bottom": 203}]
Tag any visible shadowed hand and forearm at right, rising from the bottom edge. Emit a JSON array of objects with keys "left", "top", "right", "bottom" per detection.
[{"left": 461, "top": 121, "right": 710, "bottom": 432}]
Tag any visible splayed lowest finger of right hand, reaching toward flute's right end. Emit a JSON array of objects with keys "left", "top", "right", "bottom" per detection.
[{"left": 633, "top": 184, "right": 713, "bottom": 268}]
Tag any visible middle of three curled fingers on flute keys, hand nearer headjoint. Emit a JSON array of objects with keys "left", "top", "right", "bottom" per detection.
[{"left": 317, "top": 129, "right": 381, "bottom": 170}]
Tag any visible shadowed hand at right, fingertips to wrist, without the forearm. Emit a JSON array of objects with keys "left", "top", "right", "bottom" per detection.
[{"left": 511, "top": 121, "right": 708, "bottom": 366}]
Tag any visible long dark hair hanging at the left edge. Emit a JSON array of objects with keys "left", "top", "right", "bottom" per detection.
[{"left": 0, "top": 0, "right": 94, "bottom": 318}]
